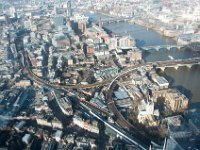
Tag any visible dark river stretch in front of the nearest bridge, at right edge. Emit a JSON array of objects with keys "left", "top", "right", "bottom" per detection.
[{"left": 159, "top": 65, "right": 200, "bottom": 110}]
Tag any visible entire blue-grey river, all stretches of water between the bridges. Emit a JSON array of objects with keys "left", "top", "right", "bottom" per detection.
[{"left": 86, "top": 13, "right": 200, "bottom": 109}]
